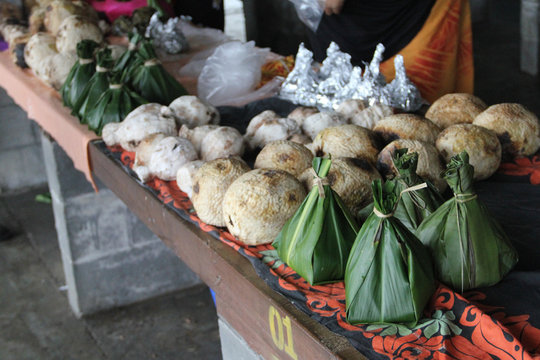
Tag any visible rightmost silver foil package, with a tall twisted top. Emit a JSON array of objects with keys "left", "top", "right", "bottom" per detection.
[{"left": 386, "top": 55, "right": 426, "bottom": 111}]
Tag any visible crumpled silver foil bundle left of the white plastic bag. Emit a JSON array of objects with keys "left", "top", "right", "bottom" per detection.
[{"left": 145, "top": 12, "right": 189, "bottom": 54}]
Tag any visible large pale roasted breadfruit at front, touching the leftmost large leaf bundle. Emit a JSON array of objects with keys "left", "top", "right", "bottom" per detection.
[{"left": 221, "top": 169, "right": 306, "bottom": 245}]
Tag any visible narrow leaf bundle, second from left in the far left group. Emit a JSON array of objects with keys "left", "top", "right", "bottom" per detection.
[{"left": 71, "top": 48, "right": 114, "bottom": 124}]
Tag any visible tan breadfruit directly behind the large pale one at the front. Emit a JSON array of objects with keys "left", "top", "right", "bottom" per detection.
[{"left": 254, "top": 140, "right": 313, "bottom": 177}]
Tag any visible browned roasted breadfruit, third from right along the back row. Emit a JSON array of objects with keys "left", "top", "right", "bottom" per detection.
[{"left": 373, "top": 114, "right": 441, "bottom": 144}]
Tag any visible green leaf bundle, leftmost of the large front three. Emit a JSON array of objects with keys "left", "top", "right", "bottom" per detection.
[{"left": 272, "top": 157, "right": 358, "bottom": 285}]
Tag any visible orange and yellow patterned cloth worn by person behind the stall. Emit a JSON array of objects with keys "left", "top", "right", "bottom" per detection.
[{"left": 381, "top": 0, "right": 474, "bottom": 103}]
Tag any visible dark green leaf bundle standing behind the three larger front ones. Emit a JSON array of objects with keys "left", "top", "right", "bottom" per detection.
[{"left": 359, "top": 149, "right": 444, "bottom": 233}]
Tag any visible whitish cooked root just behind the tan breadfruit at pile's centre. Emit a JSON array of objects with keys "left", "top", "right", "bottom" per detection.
[{"left": 245, "top": 118, "right": 300, "bottom": 149}]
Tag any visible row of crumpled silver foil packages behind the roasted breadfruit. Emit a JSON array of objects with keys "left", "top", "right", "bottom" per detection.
[{"left": 280, "top": 43, "right": 424, "bottom": 111}]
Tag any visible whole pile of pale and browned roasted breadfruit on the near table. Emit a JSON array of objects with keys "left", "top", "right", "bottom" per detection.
[{"left": 103, "top": 94, "right": 540, "bottom": 245}]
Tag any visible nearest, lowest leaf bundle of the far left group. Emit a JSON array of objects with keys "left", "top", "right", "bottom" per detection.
[{"left": 86, "top": 72, "right": 147, "bottom": 135}]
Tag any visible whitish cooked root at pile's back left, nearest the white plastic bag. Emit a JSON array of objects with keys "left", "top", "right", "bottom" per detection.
[{"left": 169, "top": 95, "right": 220, "bottom": 128}]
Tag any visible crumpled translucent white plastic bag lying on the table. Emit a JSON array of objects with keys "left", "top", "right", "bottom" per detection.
[{"left": 197, "top": 41, "right": 270, "bottom": 106}]
